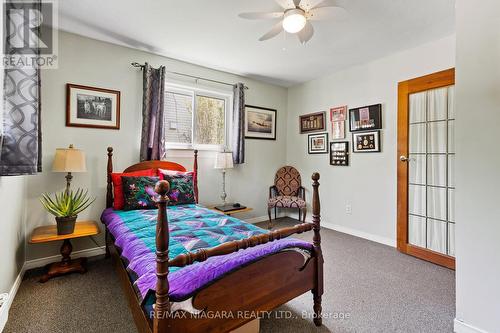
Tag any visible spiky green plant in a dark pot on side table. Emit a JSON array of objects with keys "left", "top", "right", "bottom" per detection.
[{"left": 40, "top": 188, "right": 95, "bottom": 235}]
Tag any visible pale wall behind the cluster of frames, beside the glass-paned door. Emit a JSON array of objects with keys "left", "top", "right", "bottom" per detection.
[{"left": 287, "top": 36, "right": 455, "bottom": 246}]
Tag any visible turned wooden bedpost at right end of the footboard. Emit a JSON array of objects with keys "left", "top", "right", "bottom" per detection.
[{"left": 311, "top": 172, "right": 323, "bottom": 326}]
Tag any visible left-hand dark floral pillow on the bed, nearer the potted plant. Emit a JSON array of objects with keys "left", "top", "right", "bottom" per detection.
[{"left": 122, "top": 177, "right": 160, "bottom": 210}]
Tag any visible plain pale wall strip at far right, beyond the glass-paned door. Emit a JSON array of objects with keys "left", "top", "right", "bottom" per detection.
[{"left": 455, "top": 0, "right": 500, "bottom": 333}]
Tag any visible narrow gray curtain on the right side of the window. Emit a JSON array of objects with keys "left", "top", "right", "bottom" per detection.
[{"left": 232, "top": 83, "right": 245, "bottom": 164}]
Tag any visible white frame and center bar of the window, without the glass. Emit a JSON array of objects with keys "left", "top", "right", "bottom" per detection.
[{"left": 165, "top": 83, "right": 233, "bottom": 151}]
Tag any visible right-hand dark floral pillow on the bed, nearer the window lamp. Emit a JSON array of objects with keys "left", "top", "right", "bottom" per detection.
[{"left": 162, "top": 172, "right": 195, "bottom": 206}]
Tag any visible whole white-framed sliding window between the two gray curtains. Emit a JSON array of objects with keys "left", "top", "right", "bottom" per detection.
[{"left": 164, "top": 85, "right": 232, "bottom": 150}]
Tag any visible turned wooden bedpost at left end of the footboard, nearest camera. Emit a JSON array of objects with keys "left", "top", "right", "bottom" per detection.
[{"left": 153, "top": 180, "right": 170, "bottom": 333}]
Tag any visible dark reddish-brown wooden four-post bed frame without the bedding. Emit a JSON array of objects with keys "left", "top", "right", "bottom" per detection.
[{"left": 106, "top": 147, "right": 323, "bottom": 333}]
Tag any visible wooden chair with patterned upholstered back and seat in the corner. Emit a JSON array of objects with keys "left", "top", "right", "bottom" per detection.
[{"left": 267, "top": 166, "right": 307, "bottom": 229}]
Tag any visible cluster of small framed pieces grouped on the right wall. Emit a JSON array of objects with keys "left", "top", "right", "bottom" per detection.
[{"left": 299, "top": 104, "right": 382, "bottom": 166}]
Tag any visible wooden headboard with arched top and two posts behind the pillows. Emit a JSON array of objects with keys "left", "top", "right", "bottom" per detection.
[{"left": 106, "top": 147, "right": 198, "bottom": 208}]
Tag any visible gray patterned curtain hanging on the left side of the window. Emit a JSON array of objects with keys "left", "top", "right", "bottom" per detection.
[{"left": 140, "top": 63, "right": 165, "bottom": 161}]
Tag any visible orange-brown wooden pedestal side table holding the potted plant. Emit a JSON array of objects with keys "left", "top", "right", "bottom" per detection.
[{"left": 30, "top": 221, "right": 100, "bottom": 283}]
